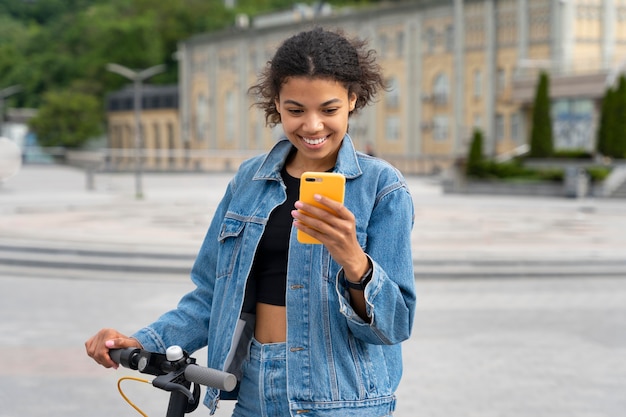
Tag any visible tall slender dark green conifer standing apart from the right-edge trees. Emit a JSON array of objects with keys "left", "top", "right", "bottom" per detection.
[{"left": 529, "top": 71, "right": 554, "bottom": 158}]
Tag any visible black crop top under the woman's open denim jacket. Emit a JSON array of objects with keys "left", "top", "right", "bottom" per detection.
[{"left": 243, "top": 167, "right": 300, "bottom": 313}]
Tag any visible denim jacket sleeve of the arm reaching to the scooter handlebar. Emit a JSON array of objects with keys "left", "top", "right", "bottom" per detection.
[{"left": 132, "top": 180, "right": 234, "bottom": 353}]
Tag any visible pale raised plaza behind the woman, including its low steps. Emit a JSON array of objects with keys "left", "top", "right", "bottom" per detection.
[{"left": 0, "top": 165, "right": 626, "bottom": 278}]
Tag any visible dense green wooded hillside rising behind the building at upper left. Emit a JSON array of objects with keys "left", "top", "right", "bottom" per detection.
[{"left": 0, "top": 0, "right": 380, "bottom": 143}]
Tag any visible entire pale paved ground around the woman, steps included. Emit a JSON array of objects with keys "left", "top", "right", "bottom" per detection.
[{"left": 0, "top": 166, "right": 626, "bottom": 417}]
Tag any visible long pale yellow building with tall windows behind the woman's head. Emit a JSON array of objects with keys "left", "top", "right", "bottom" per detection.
[{"left": 109, "top": 0, "right": 626, "bottom": 173}]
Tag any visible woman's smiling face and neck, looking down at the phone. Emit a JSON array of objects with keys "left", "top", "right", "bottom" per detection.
[{"left": 276, "top": 77, "right": 356, "bottom": 177}]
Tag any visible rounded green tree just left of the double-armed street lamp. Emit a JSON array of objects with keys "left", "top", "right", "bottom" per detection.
[{"left": 29, "top": 90, "right": 103, "bottom": 148}]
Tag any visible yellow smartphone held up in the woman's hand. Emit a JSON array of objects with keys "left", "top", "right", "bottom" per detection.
[{"left": 298, "top": 171, "right": 346, "bottom": 245}]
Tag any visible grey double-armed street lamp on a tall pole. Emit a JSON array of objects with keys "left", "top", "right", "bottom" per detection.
[{"left": 107, "top": 64, "right": 165, "bottom": 199}]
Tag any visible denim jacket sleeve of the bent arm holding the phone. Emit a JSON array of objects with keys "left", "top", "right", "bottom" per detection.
[{"left": 337, "top": 183, "right": 416, "bottom": 344}]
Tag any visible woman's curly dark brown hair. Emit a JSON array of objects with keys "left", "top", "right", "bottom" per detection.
[{"left": 248, "top": 27, "right": 385, "bottom": 126}]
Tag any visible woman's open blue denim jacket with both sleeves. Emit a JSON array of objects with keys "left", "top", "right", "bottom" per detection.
[{"left": 133, "top": 135, "right": 416, "bottom": 417}]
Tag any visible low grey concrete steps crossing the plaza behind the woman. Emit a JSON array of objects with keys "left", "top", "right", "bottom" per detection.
[{"left": 0, "top": 241, "right": 626, "bottom": 279}]
